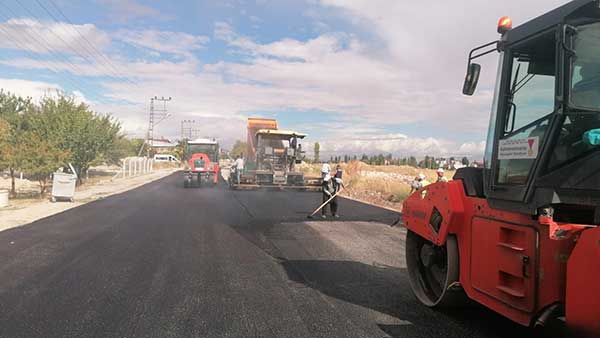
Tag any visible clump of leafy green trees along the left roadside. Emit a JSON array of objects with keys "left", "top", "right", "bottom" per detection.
[{"left": 0, "top": 90, "right": 143, "bottom": 197}]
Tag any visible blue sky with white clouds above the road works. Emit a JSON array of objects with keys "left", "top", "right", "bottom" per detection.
[{"left": 0, "top": 0, "right": 567, "bottom": 159}]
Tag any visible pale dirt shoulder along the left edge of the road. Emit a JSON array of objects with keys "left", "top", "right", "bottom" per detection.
[{"left": 0, "top": 168, "right": 177, "bottom": 231}]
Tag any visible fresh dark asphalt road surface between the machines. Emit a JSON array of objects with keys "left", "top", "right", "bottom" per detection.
[{"left": 0, "top": 174, "right": 531, "bottom": 338}]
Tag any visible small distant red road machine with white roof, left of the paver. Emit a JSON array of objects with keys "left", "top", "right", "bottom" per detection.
[{"left": 183, "top": 138, "right": 220, "bottom": 188}]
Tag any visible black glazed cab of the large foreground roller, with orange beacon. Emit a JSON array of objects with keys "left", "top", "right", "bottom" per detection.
[{"left": 463, "top": 0, "right": 600, "bottom": 217}]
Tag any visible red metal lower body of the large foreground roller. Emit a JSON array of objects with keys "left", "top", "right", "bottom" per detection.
[{"left": 403, "top": 180, "right": 600, "bottom": 337}]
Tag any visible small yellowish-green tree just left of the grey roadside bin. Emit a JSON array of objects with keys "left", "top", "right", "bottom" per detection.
[{"left": 17, "top": 132, "right": 69, "bottom": 197}]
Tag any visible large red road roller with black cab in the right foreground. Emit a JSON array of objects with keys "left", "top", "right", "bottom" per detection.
[{"left": 403, "top": 0, "right": 600, "bottom": 337}]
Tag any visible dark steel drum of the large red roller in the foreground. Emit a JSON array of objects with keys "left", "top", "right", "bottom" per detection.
[{"left": 406, "top": 230, "right": 466, "bottom": 308}]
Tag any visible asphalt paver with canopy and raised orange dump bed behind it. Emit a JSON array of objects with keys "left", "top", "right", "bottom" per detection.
[{"left": 229, "top": 118, "right": 320, "bottom": 190}]
